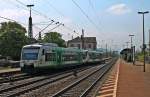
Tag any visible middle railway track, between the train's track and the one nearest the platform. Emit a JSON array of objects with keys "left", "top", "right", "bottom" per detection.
[{"left": 0, "top": 64, "right": 96, "bottom": 97}]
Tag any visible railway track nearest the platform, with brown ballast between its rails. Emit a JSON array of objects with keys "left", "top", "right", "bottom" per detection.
[{"left": 49, "top": 59, "right": 114, "bottom": 97}]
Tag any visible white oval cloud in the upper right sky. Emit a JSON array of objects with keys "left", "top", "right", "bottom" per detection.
[{"left": 107, "top": 3, "right": 131, "bottom": 15}]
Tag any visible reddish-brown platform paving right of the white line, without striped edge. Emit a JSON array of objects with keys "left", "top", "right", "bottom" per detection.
[{"left": 116, "top": 60, "right": 150, "bottom": 97}]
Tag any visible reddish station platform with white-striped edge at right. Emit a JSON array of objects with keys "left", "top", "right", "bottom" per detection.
[{"left": 96, "top": 59, "right": 150, "bottom": 97}]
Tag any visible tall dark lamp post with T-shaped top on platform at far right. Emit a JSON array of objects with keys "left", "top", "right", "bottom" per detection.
[{"left": 138, "top": 11, "right": 149, "bottom": 72}]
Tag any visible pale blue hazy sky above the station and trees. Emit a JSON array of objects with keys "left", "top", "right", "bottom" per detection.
[{"left": 0, "top": 0, "right": 150, "bottom": 50}]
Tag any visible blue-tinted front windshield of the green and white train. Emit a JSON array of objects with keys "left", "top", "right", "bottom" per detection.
[{"left": 22, "top": 47, "right": 40, "bottom": 60}]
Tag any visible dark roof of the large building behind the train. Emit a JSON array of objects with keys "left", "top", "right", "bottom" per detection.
[{"left": 68, "top": 37, "right": 96, "bottom": 43}]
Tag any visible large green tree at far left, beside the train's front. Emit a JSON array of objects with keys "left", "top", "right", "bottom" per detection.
[{"left": 0, "top": 22, "right": 29, "bottom": 60}]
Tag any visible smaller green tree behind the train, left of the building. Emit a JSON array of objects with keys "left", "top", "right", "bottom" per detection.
[{"left": 42, "top": 32, "right": 66, "bottom": 47}]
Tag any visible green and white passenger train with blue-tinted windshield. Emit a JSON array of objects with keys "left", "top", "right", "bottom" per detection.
[{"left": 20, "top": 43, "right": 106, "bottom": 73}]
